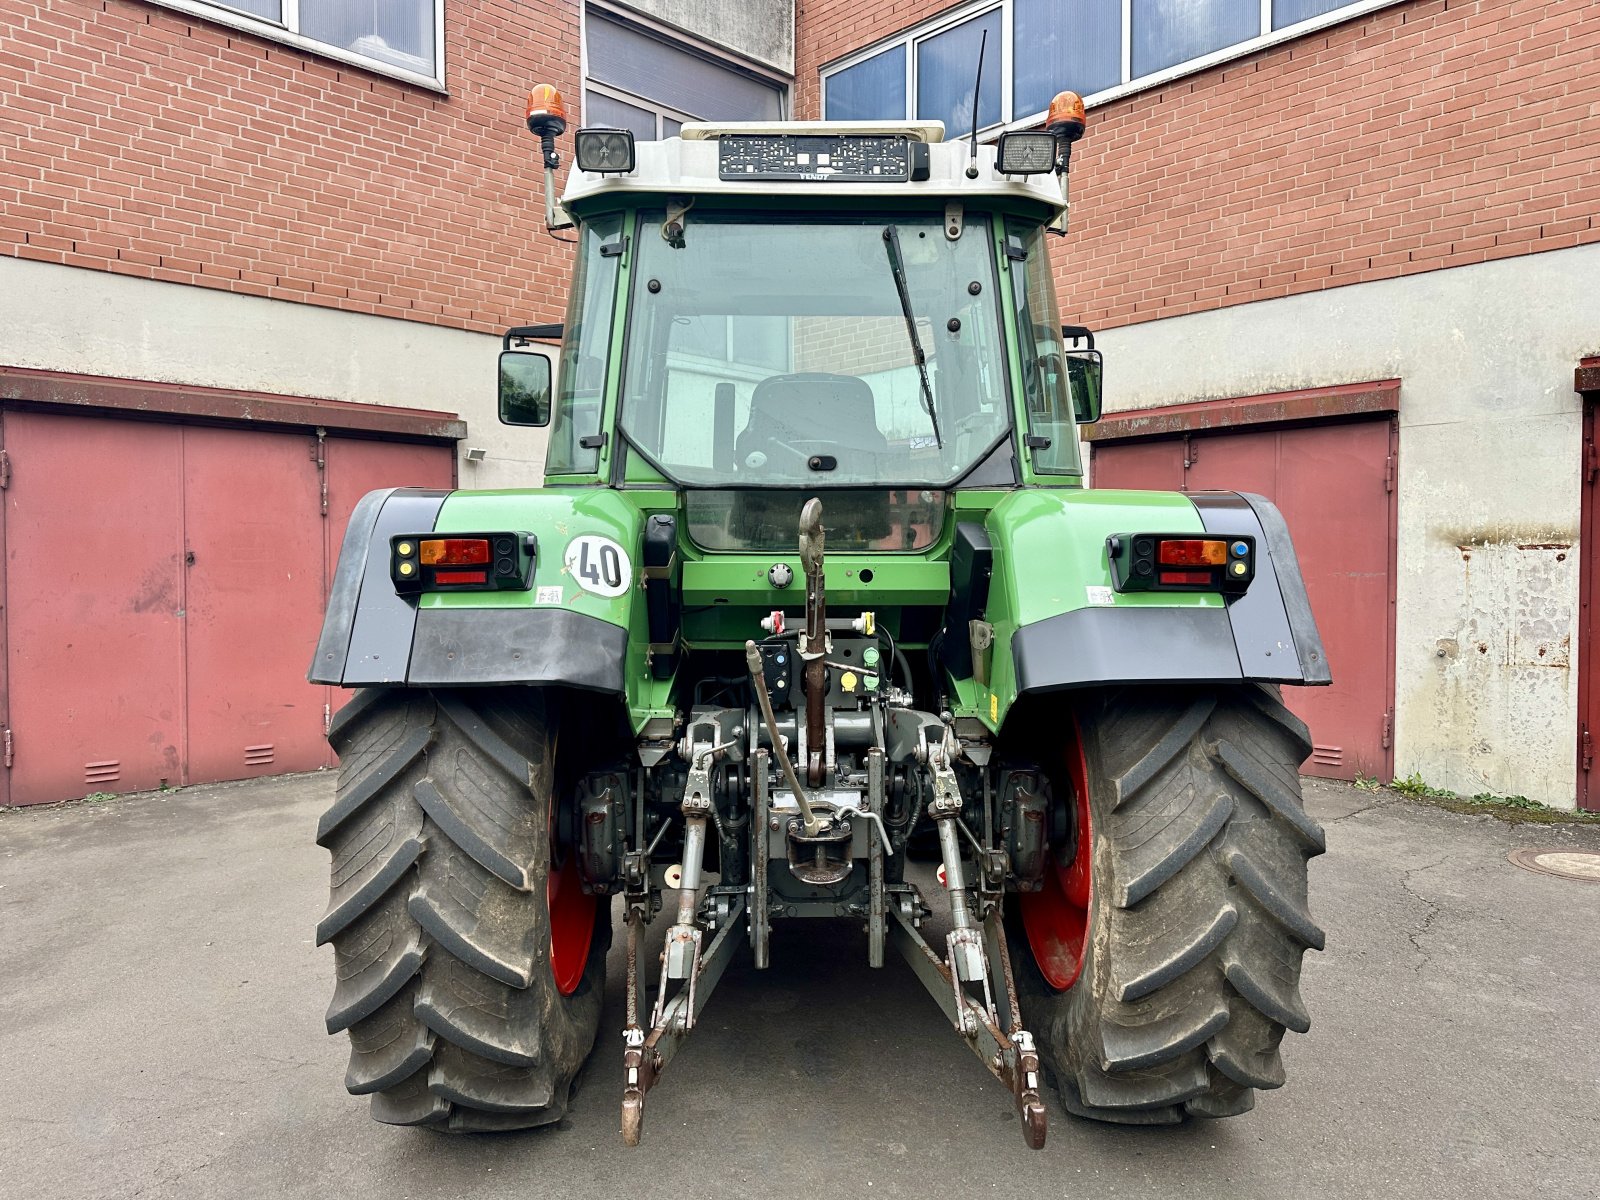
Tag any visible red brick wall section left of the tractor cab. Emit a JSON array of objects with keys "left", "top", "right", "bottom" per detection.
[{"left": 0, "top": 0, "right": 579, "bottom": 331}]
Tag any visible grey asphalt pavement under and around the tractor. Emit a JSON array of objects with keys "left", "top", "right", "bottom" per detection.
[{"left": 0, "top": 774, "right": 1600, "bottom": 1200}]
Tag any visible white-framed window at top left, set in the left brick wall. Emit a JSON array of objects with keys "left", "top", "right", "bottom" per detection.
[{"left": 154, "top": 0, "right": 445, "bottom": 91}]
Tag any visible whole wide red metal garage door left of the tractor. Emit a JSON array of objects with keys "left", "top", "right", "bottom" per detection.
[{"left": 0, "top": 390, "right": 454, "bottom": 805}]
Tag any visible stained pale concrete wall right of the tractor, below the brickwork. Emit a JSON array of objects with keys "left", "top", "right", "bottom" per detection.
[{"left": 1101, "top": 246, "right": 1600, "bottom": 808}]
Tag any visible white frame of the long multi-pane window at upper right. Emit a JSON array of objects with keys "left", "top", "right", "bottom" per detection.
[{"left": 818, "top": 0, "right": 1402, "bottom": 132}]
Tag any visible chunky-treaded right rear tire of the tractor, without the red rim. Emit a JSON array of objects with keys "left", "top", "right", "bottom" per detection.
[{"left": 1010, "top": 685, "right": 1325, "bottom": 1125}]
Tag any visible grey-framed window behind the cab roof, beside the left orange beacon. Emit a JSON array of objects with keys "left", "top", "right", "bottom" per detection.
[{"left": 582, "top": 5, "right": 787, "bottom": 141}]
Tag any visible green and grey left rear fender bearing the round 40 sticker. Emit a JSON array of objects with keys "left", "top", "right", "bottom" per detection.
[{"left": 309, "top": 488, "right": 643, "bottom": 694}]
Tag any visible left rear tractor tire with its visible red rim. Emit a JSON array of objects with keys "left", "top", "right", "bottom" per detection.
[{"left": 317, "top": 688, "right": 611, "bottom": 1131}]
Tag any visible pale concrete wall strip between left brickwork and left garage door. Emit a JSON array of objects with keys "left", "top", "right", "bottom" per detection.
[{"left": 0, "top": 258, "right": 546, "bottom": 488}]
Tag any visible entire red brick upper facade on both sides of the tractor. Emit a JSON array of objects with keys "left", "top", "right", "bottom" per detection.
[{"left": 9, "top": 0, "right": 1600, "bottom": 340}]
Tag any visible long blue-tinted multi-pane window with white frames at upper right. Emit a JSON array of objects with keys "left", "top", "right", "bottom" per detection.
[{"left": 822, "top": 0, "right": 1398, "bottom": 128}]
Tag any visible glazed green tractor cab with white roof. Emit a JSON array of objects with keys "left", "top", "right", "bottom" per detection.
[{"left": 502, "top": 118, "right": 1099, "bottom": 531}]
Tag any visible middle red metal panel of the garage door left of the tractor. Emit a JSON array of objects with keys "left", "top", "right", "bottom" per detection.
[{"left": 184, "top": 427, "right": 326, "bottom": 779}]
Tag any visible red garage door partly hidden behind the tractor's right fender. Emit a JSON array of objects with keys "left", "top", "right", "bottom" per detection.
[{"left": 1091, "top": 380, "right": 1395, "bottom": 781}]
